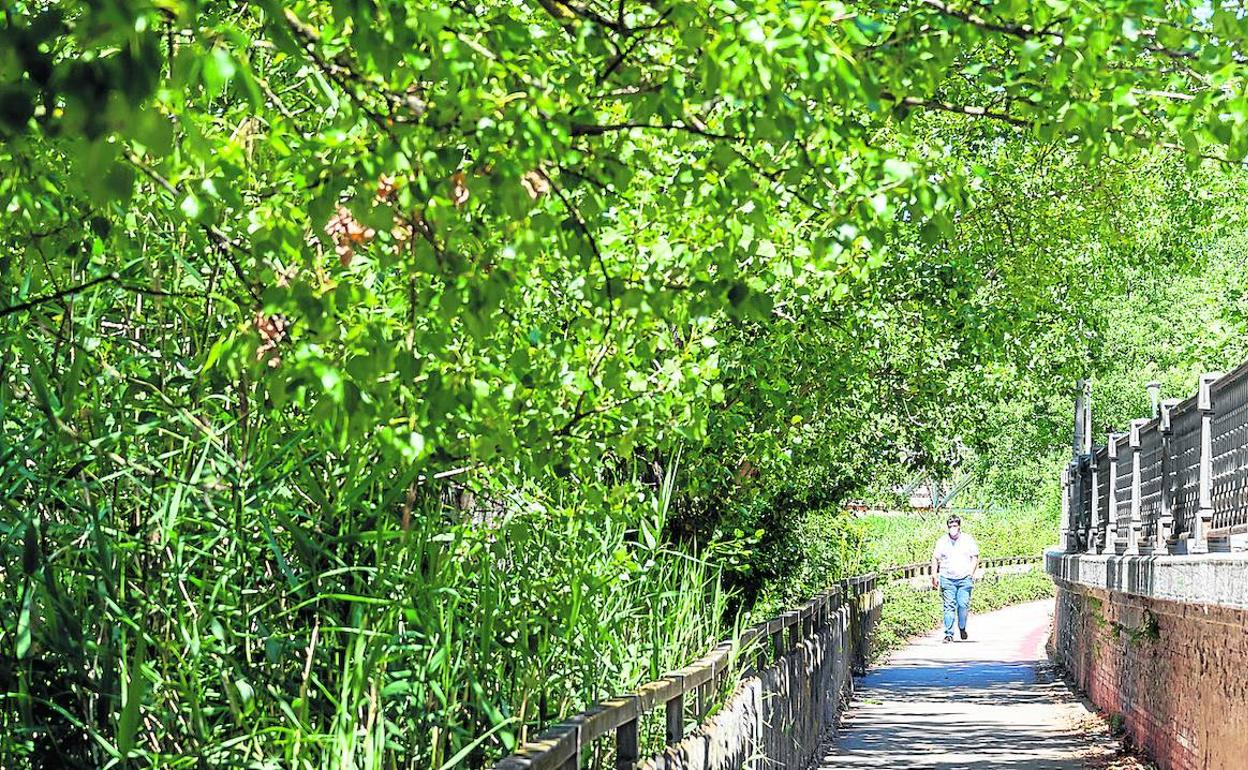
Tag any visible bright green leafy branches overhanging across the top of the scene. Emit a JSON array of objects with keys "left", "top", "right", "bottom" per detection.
[{"left": 0, "top": 0, "right": 1248, "bottom": 469}]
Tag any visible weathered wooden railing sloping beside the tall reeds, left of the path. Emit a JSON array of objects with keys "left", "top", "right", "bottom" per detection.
[{"left": 495, "top": 574, "right": 876, "bottom": 770}]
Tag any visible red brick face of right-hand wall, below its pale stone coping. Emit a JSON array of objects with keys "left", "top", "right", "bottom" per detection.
[{"left": 1050, "top": 579, "right": 1248, "bottom": 770}]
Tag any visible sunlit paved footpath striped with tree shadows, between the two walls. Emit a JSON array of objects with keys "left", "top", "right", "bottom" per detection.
[{"left": 817, "top": 599, "right": 1117, "bottom": 770}]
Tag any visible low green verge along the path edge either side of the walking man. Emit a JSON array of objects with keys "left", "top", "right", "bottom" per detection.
[{"left": 871, "top": 567, "right": 1053, "bottom": 661}]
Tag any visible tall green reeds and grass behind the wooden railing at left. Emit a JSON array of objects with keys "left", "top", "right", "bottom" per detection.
[{"left": 0, "top": 378, "right": 728, "bottom": 770}]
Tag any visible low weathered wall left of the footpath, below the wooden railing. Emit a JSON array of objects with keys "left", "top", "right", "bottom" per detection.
[{"left": 638, "top": 589, "right": 884, "bottom": 770}]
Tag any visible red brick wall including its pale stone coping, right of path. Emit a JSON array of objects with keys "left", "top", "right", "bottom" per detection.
[{"left": 1046, "top": 553, "right": 1248, "bottom": 770}]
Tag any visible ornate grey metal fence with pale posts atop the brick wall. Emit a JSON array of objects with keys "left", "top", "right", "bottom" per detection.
[{"left": 1062, "top": 363, "right": 1248, "bottom": 554}]
